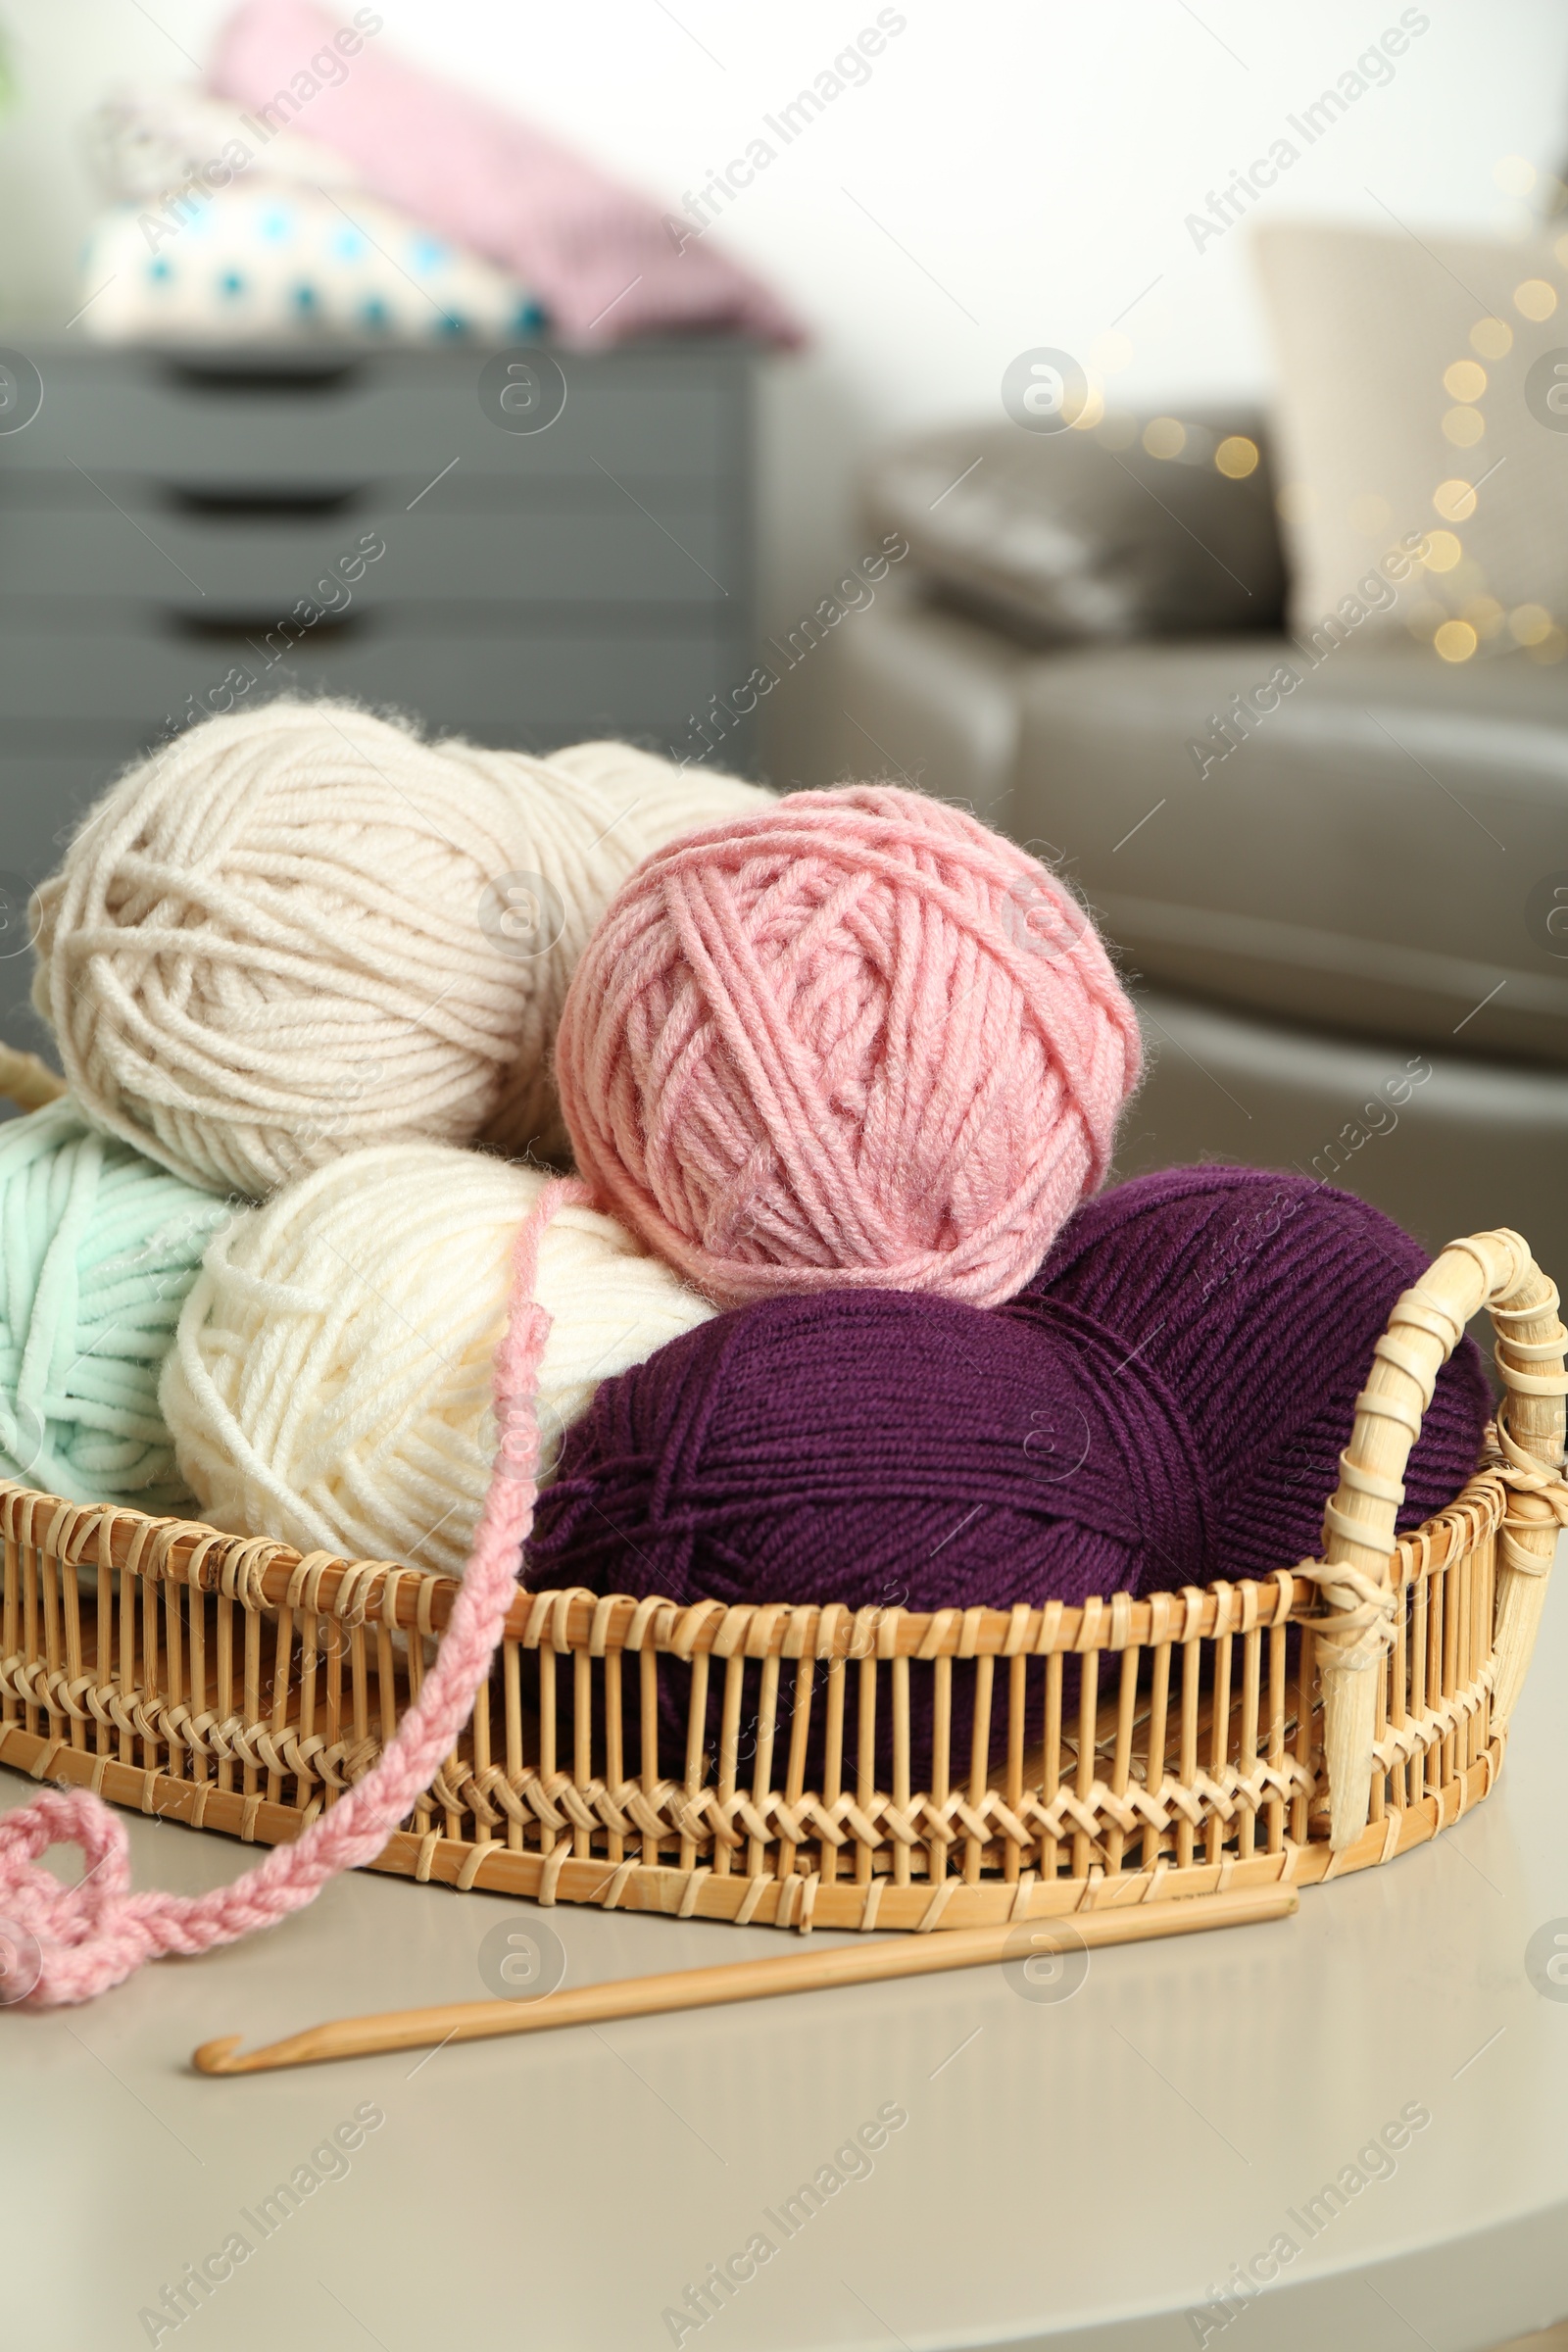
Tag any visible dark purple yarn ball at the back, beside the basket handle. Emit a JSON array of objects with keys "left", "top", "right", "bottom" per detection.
[{"left": 999, "top": 1166, "right": 1491, "bottom": 1583}]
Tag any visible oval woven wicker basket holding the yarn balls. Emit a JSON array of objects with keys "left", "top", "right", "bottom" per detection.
[{"left": 0, "top": 1233, "right": 1568, "bottom": 1929}]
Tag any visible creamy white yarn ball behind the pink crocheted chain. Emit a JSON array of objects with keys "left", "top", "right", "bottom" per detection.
[{"left": 160, "top": 1143, "right": 714, "bottom": 1576}]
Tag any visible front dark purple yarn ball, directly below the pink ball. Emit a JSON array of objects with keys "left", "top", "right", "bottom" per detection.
[{"left": 526, "top": 1289, "right": 1218, "bottom": 1609}]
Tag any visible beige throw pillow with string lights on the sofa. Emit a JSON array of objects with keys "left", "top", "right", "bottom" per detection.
[{"left": 1253, "top": 223, "right": 1568, "bottom": 661}]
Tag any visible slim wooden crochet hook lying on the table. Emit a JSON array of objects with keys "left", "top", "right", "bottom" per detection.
[{"left": 190, "top": 1886, "right": 1296, "bottom": 2075}]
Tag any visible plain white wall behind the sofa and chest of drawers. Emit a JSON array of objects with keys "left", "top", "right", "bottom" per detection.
[{"left": 0, "top": 0, "right": 1568, "bottom": 776}]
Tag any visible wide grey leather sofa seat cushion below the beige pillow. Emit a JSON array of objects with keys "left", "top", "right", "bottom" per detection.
[{"left": 1010, "top": 637, "right": 1568, "bottom": 1068}]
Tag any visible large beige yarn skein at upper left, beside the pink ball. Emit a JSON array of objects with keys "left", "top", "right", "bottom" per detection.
[{"left": 33, "top": 701, "right": 771, "bottom": 1200}]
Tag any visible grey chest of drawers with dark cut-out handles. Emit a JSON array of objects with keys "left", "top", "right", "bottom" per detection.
[{"left": 0, "top": 339, "right": 755, "bottom": 1045}]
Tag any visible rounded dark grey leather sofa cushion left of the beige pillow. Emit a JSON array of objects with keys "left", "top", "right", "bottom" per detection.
[{"left": 867, "top": 410, "right": 1284, "bottom": 642}]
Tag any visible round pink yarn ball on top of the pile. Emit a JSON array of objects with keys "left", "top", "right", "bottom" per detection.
[{"left": 558, "top": 786, "right": 1140, "bottom": 1305}]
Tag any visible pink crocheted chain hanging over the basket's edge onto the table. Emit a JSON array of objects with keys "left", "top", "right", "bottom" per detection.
[{"left": 0, "top": 1178, "right": 590, "bottom": 2006}]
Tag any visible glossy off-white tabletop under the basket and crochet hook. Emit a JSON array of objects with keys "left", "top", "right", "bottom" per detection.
[{"left": 0, "top": 1543, "right": 1568, "bottom": 2352}]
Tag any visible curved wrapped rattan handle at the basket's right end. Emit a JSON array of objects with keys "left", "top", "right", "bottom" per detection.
[{"left": 1316, "top": 1228, "right": 1568, "bottom": 1853}]
